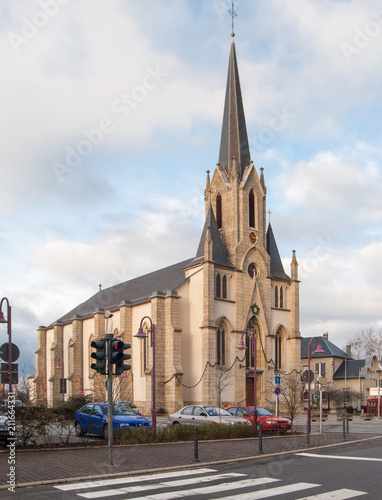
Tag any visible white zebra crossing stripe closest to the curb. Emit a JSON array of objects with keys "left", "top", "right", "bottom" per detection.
[{"left": 55, "top": 468, "right": 217, "bottom": 491}]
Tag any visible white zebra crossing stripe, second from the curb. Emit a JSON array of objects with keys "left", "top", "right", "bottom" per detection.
[{"left": 78, "top": 472, "right": 251, "bottom": 498}]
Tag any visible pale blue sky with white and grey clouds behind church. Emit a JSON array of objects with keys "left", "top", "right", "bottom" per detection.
[{"left": 0, "top": 0, "right": 382, "bottom": 370}]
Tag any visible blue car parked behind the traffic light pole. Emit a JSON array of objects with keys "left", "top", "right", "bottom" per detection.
[{"left": 74, "top": 403, "right": 152, "bottom": 439}]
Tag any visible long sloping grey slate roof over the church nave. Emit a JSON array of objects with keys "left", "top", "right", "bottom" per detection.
[{"left": 52, "top": 259, "right": 191, "bottom": 323}]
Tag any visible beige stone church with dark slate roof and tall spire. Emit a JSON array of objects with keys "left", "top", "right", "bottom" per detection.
[{"left": 31, "top": 35, "right": 301, "bottom": 413}]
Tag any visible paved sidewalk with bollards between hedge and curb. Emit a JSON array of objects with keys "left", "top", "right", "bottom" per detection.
[{"left": 0, "top": 414, "right": 382, "bottom": 489}]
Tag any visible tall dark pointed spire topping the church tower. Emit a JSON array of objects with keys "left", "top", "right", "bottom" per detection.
[{"left": 219, "top": 37, "right": 251, "bottom": 179}]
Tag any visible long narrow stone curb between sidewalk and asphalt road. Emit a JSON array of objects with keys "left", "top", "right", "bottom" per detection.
[{"left": 0, "top": 436, "right": 382, "bottom": 491}]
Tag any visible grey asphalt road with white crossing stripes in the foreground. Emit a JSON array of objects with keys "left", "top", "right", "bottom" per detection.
[{"left": 1, "top": 439, "right": 382, "bottom": 500}]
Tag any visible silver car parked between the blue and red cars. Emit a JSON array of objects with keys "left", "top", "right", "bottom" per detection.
[{"left": 167, "top": 405, "right": 251, "bottom": 425}]
